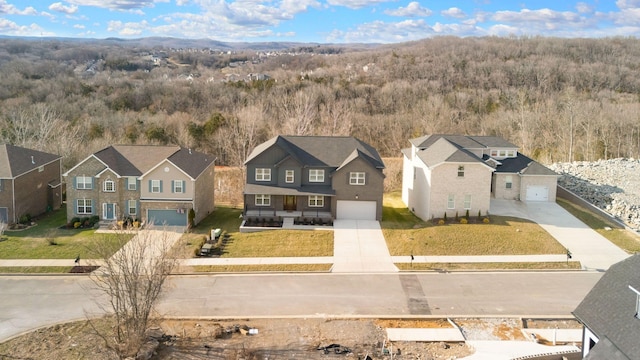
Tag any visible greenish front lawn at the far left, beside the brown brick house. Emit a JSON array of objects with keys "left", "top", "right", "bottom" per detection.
[{"left": 0, "top": 208, "right": 125, "bottom": 259}]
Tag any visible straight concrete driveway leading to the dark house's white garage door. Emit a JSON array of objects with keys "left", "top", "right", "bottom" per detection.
[{"left": 331, "top": 220, "right": 398, "bottom": 273}]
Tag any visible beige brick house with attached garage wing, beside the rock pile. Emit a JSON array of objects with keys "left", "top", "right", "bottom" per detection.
[{"left": 402, "top": 135, "right": 558, "bottom": 220}]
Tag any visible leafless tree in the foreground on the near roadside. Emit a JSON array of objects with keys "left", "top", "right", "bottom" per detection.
[{"left": 91, "top": 230, "right": 176, "bottom": 359}]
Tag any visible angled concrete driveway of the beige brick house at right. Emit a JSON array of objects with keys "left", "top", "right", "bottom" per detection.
[{"left": 490, "top": 199, "right": 629, "bottom": 271}]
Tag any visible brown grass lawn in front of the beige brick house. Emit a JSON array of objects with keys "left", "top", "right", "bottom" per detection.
[{"left": 382, "top": 192, "right": 565, "bottom": 256}]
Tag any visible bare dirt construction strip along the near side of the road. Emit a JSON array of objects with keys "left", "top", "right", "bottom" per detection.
[{"left": 0, "top": 318, "right": 577, "bottom": 360}]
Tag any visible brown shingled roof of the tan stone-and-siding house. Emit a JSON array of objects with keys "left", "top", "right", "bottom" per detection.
[{"left": 67, "top": 145, "right": 215, "bottom": 179}]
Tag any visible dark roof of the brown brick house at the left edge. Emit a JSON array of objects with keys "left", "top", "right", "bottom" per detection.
[{"left": 0, "top": 144, "right": 61, "bottom": 179}]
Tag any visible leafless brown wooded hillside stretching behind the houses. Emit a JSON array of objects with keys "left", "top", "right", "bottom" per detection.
[{"left": 0, "top": 37, "right": 640, "bottom": 167}]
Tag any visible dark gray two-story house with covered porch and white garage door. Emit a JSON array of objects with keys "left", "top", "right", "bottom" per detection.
[{"left": 244, "top": 136, "right": 384, "bottom": 220}]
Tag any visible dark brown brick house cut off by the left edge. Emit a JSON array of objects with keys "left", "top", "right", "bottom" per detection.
[{"left": 0, "top": 144, "right": 62, "bottom": 224}]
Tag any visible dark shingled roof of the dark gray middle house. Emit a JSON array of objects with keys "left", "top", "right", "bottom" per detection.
[{"left": 245, "top": 135, "right": 384, "bottom": 169}]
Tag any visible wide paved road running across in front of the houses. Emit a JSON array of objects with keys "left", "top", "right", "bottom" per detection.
[{"left": 0, "top": 272, "right": 602, "bottom": 341}]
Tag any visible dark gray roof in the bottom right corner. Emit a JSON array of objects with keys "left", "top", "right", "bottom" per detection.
[{"left": 573, "top": 254, "right": 640, "bottom": 359}]
